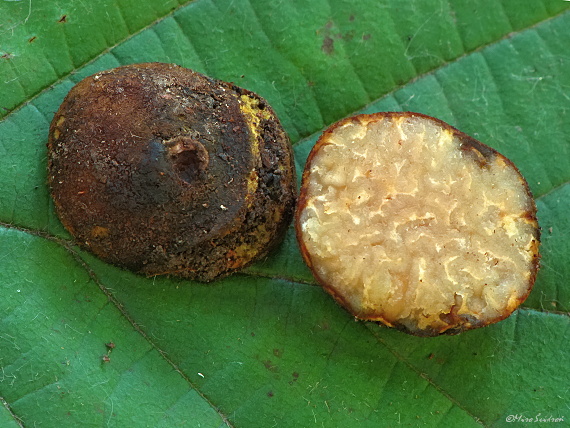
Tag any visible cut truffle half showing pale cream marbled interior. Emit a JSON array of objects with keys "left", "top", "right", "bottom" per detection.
[{"left": 296, "top": 113, "right": 540, "bottom": 336}]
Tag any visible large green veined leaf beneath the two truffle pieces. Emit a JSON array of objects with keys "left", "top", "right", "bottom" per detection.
[{"left": 0, "top": 0, "right": 570, "bottom": 428}]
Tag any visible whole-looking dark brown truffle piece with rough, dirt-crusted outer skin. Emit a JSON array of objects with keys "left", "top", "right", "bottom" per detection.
[{"left": 48, "top": 63, "right": 295, "bottom": 281}]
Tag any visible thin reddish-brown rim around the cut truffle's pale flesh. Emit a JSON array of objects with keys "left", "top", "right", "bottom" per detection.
[{"left": 295, "top": 112, "right": 540, "bottom": 336}]
